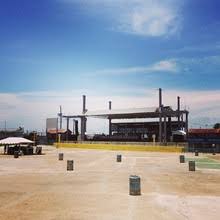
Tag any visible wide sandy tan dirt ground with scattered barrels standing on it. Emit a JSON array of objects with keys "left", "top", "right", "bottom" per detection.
[{"left": 0, "top": 148, "right": 220, "bottom": 220}]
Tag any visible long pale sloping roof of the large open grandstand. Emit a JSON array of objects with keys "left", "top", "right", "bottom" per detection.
[{"left": 63, "top": 106, "right": 186, "bottom": 119}]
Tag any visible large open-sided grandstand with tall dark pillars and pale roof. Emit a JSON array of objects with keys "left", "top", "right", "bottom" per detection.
[{"left": 58, "top": 89, "right": 189, "bottom": 143}]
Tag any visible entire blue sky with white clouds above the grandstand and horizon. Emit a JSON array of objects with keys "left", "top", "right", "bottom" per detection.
[{"left": 0, "top": 0, "right": 220, "bottom": 131}]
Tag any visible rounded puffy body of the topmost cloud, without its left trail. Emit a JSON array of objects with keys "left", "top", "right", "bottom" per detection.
[{"left": 119, "top": 1, "right": 180, "bottom": 36}]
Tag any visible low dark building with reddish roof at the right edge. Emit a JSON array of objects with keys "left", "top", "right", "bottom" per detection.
[{"left": 187, "top": 128, "right": 220, "bottom": 152}]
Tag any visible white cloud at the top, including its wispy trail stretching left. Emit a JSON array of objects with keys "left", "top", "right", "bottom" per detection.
[{"left": 61, "top": 0, "right": 183, "bottom": 37}]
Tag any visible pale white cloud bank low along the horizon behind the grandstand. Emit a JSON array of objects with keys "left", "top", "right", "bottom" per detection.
[{"left": 0, "top": 88, "right": 220, "bottom": 133}]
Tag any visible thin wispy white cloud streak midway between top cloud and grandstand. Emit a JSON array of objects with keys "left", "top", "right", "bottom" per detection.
[{"left": 92, "top": 60, "right": 179, "bottom": 75}]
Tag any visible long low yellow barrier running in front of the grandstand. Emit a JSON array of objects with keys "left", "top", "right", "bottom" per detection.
[{"left": 54, "top": 143, "right": 184, "bottom": 153}]
